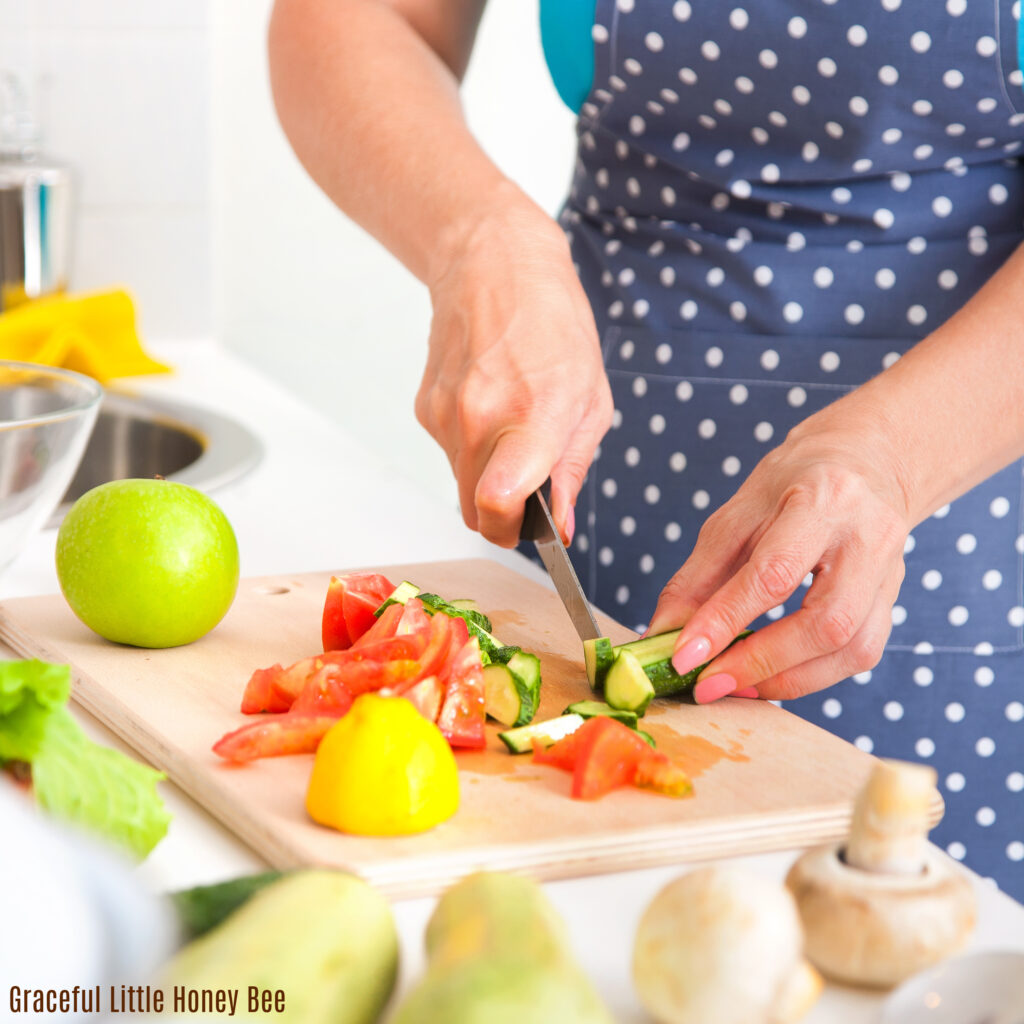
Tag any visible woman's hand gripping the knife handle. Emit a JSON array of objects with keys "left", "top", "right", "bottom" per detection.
[{"left": 416, "top": 190, "right": 612, "bottom": 548}]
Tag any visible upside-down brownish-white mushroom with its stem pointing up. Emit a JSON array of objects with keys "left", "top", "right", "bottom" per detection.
[{"left": 785, "top": 761, "right": 975, "bottom": 987}]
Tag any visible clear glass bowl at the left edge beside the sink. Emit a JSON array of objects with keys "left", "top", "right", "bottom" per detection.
[{"left": 0, "top": 359, "right": 103, "bottom": 572}]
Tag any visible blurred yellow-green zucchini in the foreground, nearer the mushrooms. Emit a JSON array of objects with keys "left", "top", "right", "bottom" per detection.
[{"left": 390, "top": 872, "right": 612, "bottom": 1024}]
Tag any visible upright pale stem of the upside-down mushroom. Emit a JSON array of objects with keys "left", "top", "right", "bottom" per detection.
[{"left": 845, "top": 761, "right": 936, "bottom": 874}]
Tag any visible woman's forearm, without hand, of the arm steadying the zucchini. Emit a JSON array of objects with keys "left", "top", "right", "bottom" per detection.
[{"left": 794, "top": 247, "right": 1024, "bottom": 523}]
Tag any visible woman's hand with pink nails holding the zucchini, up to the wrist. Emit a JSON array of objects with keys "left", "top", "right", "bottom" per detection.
[{"left": 649, "top": 403, "right": 912, "bottom": 703}]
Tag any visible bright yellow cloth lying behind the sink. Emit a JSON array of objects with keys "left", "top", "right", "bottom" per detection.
[{"left": 0, "top": 291, "right": 171, "bottom": 383}]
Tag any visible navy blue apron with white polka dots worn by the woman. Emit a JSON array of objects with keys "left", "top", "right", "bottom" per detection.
[{"left": 561, "top": 0, "right": 1024, "bottom": 899}]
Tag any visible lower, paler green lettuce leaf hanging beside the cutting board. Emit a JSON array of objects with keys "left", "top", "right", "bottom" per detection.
[{"left": 32, "top": 708, "right": 171, "bottom": 859}]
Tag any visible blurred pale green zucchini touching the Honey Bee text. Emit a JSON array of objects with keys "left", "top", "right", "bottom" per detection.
[{"left": 163, "top": 869, "right": 398, "bottom": 1024}]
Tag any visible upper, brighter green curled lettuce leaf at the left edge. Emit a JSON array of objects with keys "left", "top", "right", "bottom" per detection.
[{"left": 0, "top": 660, "right": 71, "bottom": 762}]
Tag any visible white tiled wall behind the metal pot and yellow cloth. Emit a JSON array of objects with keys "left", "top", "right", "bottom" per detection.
[{"left": 0, "top": 0, "right": 213, "bottom": 339}]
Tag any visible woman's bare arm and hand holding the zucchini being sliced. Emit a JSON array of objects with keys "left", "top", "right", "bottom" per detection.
[{"left": 650, "top": 241, "right": 1024, "bottom": 700}]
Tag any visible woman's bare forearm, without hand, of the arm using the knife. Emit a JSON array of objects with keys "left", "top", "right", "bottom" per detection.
[{"left": 269, "top": 0, "right": 543, "bottom": 282}]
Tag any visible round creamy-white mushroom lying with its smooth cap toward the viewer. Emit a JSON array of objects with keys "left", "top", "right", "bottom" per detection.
[{"left": 633, "top": 866, "right": 822, "bottom": 1024}]
